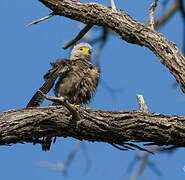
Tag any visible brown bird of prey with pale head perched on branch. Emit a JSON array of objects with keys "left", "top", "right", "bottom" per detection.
[{"left": 27, "top": 43, "right": 100, "bottom": 151}]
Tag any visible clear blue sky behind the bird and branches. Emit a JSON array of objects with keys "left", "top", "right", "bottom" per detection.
[{"left": 0, "top": 0, "right": 185, "bottom": 180}]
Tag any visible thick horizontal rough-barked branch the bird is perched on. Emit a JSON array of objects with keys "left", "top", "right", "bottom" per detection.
[{"left": 0, "top": 106, "right": 185, "bottom": 147}]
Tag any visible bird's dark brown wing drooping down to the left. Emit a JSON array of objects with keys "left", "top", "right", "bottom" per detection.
[{"left": 26, "top": 59, "right": 70, "bottom": 107}]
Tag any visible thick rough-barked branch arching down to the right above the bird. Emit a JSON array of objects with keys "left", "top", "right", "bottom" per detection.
[{"left": 39, "top": 0, "right": 185, "bottom": 92}]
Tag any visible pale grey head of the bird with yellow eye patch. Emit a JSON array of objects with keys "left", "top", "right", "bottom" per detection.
[{"left": 70, "top": 43, "right": 92, "bottom": 61}]
